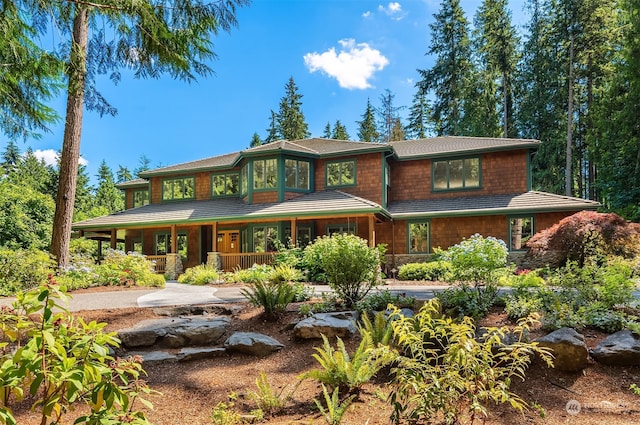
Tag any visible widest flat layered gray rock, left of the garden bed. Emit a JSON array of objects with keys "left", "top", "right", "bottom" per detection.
[{"left": 118, "top": 316, "right": 230, "bottom": 348}]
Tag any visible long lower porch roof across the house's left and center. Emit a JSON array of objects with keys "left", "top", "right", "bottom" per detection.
[{"left": 73, "top": 190, "right": 385, "bottom": 229}]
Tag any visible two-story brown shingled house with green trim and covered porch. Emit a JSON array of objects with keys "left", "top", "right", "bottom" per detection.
[{"left": 73, "top": 137, "right": 599, "bottom": 276}]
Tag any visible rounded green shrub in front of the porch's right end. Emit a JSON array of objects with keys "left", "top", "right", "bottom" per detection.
[{"left": 305, "top": 234, "right": 382, "bottom": 308}]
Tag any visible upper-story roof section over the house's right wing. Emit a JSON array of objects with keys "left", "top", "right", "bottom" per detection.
[{"left": 391, "top": 136, "right": 540, "bottom": 159}]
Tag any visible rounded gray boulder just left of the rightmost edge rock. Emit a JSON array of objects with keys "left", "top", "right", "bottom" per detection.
[{"left": 536, "top": 328, "right": 589, "bottom": 372}]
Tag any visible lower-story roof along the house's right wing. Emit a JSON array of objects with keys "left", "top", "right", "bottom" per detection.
[{"left": 387, "top": 191, "right": 600, "bottom": 219}]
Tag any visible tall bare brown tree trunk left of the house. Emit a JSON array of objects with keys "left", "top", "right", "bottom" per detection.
[{"left": 51, "top": 5, "right": 89, "bottom": 267}]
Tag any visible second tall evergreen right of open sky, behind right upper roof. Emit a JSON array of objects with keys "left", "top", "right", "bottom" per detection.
[{"left": 475, "top": 0, "right": 519, "bottom": 137}]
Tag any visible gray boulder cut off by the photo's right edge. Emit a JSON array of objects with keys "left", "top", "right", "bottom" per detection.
[{"left": 591, "top": 330, "right": 640, "bottom": 366}]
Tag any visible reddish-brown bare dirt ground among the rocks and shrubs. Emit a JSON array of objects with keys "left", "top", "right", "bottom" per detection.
[{"left": 11, "top": 286, "right": 640, "bottom": 425}]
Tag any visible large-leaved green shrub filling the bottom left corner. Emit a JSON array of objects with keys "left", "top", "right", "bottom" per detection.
[{"left": 0, "top": 280, "right": 155, "bottom": 424}]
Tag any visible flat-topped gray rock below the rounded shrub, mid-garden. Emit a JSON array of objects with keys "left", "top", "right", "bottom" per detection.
[{"left": 293, "top": 311, "right": 358, "bottom": 339}]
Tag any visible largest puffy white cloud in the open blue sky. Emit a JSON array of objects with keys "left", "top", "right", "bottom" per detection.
[{"left": 304, "top": 38, "right": 389, "bottom": 90}]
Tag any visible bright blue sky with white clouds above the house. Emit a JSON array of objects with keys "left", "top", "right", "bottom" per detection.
[{"left": 13, "top": 0, "right": 527, "bottom": 182}]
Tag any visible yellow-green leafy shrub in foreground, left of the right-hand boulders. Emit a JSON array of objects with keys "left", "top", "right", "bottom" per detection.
[{"left": 390, "top": 299, "right": 551, "bottom": 424}]
